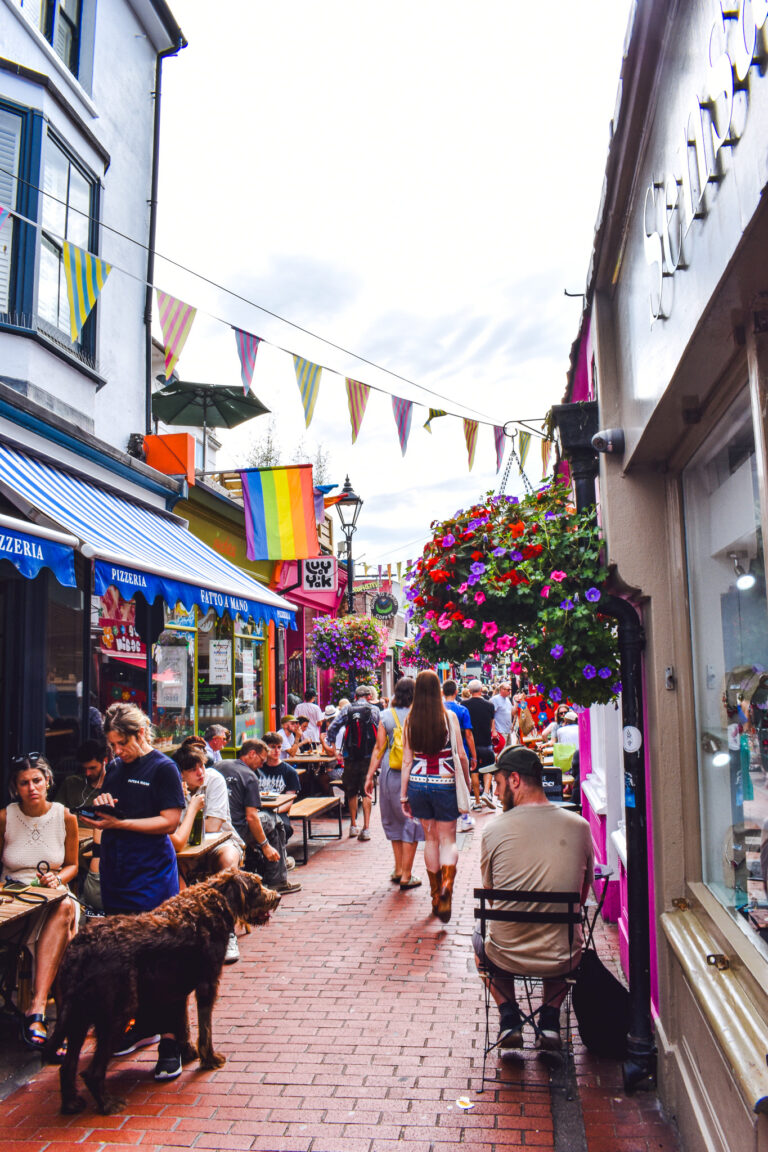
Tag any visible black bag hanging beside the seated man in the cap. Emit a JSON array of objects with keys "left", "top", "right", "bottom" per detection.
[{"left": 572, "top": 948, "right": 630, "bottom": 1060}]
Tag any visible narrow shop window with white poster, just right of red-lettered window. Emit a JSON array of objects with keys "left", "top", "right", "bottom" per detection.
[{"left": 152, "top": 605, "right": 197, "bottom": 753}]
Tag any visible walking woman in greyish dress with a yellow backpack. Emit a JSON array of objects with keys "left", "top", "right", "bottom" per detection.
[{"left": 365, "top": 676, "right": 424, "bottom": 892}]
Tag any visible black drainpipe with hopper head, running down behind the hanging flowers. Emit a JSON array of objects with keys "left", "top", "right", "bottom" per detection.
[{"left": 553, "top": 401, "right": 656, "bottom": 1092}]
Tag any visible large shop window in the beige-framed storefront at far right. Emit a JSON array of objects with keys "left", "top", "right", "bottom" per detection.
[{"left": 683, "top": 391, "right": 768, "bottom": 955}]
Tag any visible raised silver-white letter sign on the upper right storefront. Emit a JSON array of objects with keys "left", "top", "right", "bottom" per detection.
[{"left": 642, "top": 0, "right": 768, "bottom": 325}]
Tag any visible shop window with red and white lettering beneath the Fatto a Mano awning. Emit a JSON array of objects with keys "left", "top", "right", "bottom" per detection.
[{"left": 91, "top": 588, "right": 146, "bottom": 732}]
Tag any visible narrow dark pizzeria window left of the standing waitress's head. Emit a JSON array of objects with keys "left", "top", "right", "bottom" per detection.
[{"left": 45, "top": 574, "right": 83, "bottom": 774}]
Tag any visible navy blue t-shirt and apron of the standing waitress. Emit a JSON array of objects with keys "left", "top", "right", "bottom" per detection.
[{"left": 99, "top": 749, "right": 184, "bottom": 912}]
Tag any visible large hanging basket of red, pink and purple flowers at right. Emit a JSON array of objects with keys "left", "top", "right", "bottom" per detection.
[{"left": 405, "top": 480, "right": 621, "bottom": 705}]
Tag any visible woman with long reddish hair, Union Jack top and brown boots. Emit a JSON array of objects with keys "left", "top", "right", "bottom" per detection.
[{"left": 401, "top": 672, "right": 470, "bottom": 924}]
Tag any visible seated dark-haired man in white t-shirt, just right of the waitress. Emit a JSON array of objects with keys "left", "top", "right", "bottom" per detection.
[{"left": 170, "top": 746, "right": 245, "bottom": 964}]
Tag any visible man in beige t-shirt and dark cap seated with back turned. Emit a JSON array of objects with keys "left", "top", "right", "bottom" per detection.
[{"left": 472, "top": 745, "right": 593, "bottom": 1049}]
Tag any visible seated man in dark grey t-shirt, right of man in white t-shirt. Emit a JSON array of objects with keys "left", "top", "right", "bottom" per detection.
[{"left": 214, "top": 740, "right": 302, "bottom": 894}]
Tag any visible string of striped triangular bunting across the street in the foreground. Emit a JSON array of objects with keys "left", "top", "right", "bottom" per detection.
[{"left": 0, "top": 205, "right": 550, "bottom": 479}]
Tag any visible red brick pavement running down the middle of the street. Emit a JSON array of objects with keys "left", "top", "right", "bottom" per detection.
[{"left": 0, "top": 811, "right": 678, "bottom": 1152}]
